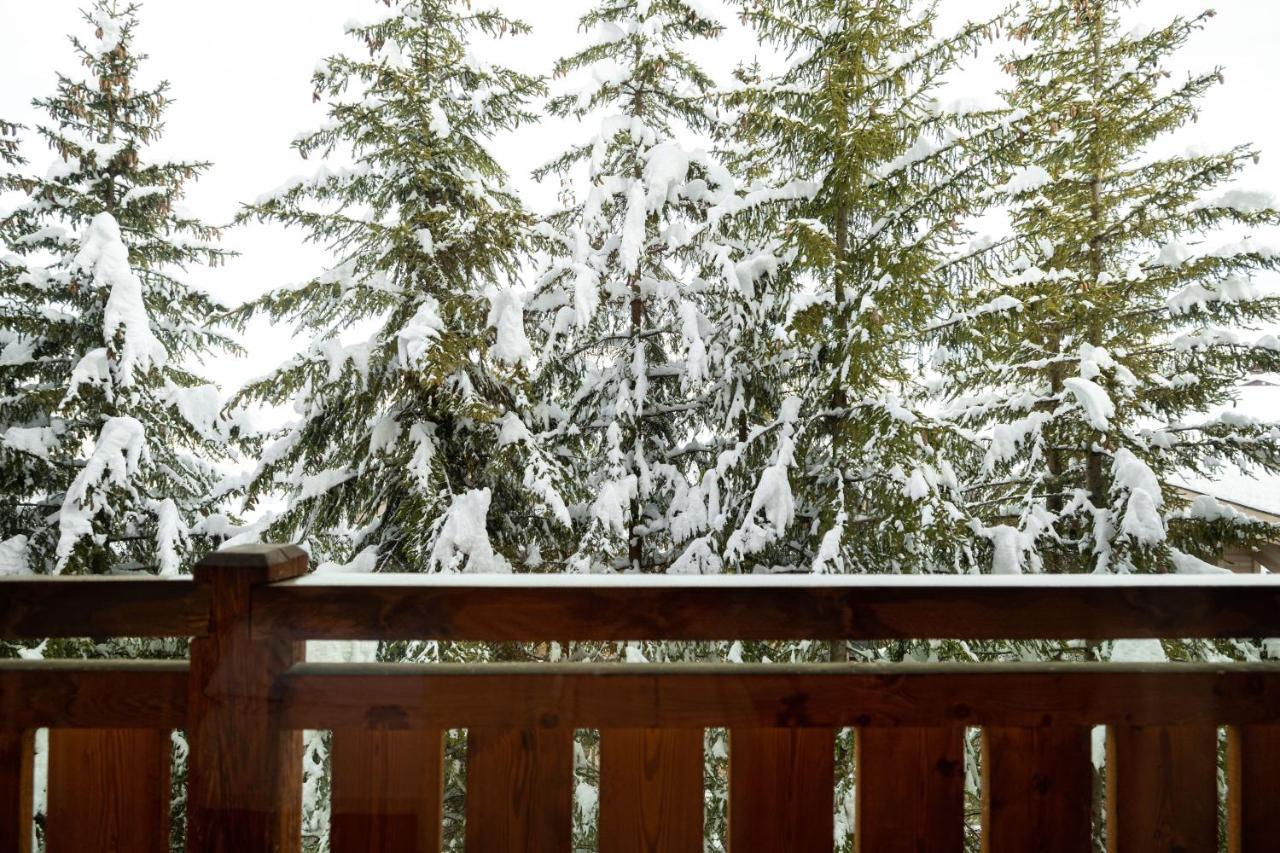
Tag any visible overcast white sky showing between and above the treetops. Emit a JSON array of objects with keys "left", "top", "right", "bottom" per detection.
[{"left": 0, "top": 0, "right": 1280, "bottom": 389}]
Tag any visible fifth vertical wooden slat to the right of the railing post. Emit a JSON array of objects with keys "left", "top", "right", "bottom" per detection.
[{"left": 854, "top": 726, "right": 964, "bottom": 853}]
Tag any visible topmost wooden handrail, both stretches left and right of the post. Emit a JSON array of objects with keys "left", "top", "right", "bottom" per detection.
[{"left": 0, "top": 563, "right": 1280, "bottom": 642}]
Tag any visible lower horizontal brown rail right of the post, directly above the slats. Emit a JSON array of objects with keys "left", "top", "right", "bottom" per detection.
[{"left": 283, "top": 663, "right": 1280, "bottom": 729}]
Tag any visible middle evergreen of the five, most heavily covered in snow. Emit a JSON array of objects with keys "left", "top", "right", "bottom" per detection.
[{"left": 531, "top": 0, "right": 733, "bottom": 571}]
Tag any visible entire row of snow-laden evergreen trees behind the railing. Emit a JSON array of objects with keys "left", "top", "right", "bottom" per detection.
[{"left": 0, "top": 0, "right": 1280, "bottom": 584}]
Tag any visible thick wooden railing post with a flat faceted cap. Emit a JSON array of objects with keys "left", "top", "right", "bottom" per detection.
[{"left": 187, "top": 546, "right": 307, "bottom": 853}]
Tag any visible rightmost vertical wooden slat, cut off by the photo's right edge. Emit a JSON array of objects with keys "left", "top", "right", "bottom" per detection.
[{"left": 1226, "top": 725, "right": 1280, "bottom": 853}]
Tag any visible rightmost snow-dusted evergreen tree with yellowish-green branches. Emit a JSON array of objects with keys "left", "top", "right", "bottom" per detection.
[{"left": 945, "top": 0, "right": 1280, "bottom": 573}]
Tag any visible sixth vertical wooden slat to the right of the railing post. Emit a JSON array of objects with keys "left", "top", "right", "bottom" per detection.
[{"left": 982, "top": 726, "right": 1093, "bottom": 853}]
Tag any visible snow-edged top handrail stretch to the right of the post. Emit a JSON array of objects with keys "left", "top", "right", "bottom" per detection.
[{"left": 253, "top": 576, "right": 1280, "bottom": 642}]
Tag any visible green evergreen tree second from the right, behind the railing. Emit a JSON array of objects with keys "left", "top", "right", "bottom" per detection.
[{"left": 731, "top": 0, "right": 1012, "bottom": 571}]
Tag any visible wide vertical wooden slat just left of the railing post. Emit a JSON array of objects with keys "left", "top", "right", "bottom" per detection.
[{"left": 45, "top": 729, "right": 172, "bottom": 853}]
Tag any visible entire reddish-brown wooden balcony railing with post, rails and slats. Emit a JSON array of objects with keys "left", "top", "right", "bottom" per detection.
[{"left": 0, "top": 547, "right": 1280, "bottom": 853}]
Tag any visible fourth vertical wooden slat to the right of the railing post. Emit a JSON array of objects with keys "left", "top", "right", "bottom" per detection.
[{"left": 728, "top": 729, "right": 836, "bottom": 853}]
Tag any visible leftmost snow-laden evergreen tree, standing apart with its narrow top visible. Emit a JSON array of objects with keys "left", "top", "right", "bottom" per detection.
[{"left": 0, "top": 0, "right": 232, "bottom": 574}]
